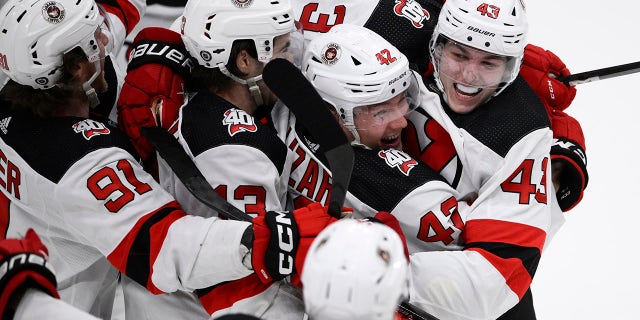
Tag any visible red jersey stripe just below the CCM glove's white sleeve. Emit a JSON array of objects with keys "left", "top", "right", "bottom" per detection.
[{"left": 199, "top": 273, "right": 272, "bottom": 314}]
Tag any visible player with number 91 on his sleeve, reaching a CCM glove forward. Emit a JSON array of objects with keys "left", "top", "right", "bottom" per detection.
[{"left": 0, "top": 0, "right": 332, "bottom": 319}]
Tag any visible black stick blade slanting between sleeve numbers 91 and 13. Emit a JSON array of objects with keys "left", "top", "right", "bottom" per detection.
[{"left": 140, "top": 127, "right": 253, "bottom": 222}]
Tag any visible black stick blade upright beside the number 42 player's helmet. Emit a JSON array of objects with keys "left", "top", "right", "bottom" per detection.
[{"left": 262, "top": 59, "right": 354, "bottom": 218}]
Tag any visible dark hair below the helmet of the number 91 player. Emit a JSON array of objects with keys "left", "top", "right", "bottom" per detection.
[{"left": 0, "top": 47, "right": 88, "bottom": 118}]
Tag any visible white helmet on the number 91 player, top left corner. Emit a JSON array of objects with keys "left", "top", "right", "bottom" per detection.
[{"left": 0, "top": 0, "right": 103, "bottom": 89}]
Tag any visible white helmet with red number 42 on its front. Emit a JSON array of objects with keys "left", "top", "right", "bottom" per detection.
[{"left": 302, "top": 24, "right": 419, "bottom": 139}]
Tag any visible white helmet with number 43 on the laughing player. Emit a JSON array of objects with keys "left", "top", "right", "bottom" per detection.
[{"left": 429, "top": 0, "right": 529, "bottom": 96}]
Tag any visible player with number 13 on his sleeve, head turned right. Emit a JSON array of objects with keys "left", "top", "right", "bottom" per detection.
[{"left": 144, "top": 0, "right": 314, "bottom": 319}]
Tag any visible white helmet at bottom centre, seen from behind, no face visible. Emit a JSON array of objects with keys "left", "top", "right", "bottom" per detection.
[{"left": 302, "top": 219, "right": 409, "bottom": 320}]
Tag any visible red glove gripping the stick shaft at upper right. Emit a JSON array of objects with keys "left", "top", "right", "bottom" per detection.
[{"left": 520, "top": 44, "right": 576, "bottom": 110}]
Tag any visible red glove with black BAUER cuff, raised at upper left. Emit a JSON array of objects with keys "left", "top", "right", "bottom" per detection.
[{"left": 118, "top": 27, "right": 193, "bottom": 161}]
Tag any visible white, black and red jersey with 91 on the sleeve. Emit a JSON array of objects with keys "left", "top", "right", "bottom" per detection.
[{"left": 0, "top": 102, "right": 252, "bottom": 319}]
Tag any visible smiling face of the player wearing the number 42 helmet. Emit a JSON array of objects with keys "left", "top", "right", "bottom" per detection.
[{"left": 353, "top": 92, "right": 411, "bottom": 150}]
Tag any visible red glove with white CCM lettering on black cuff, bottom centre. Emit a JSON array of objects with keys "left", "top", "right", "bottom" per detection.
[{"left": 251, "top": 202, "right": 337, "bottom": 284}]
